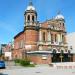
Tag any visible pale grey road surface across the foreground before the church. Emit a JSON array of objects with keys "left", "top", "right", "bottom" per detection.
[{"left": 0, "top": 65, "right": 75, "bottom": 75}]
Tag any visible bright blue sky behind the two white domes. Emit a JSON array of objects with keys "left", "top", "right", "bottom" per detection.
[{"left": 0, "top": 0, "right": 75, "bottom": 44}]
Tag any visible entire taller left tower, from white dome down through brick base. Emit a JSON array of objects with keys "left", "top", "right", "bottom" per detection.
[{"left": 24, "top": 0, "right": 38, "bottom": 50}]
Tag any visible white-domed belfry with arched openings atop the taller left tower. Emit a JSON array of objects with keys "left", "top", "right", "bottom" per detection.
[{"left": 24, "top": 0, "right": 37, "bottom": 26}]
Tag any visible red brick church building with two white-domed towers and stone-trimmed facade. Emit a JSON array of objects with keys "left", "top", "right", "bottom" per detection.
[{"left": 13, "top": 2, "right": 74, "bottom": 64}]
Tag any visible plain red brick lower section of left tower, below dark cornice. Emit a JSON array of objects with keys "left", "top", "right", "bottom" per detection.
[{"left": 25, "top": 30, "right": 38, "bottom": 50}]
